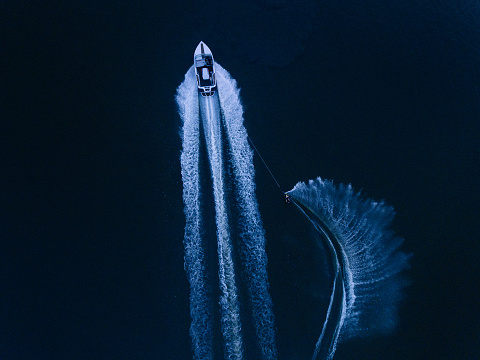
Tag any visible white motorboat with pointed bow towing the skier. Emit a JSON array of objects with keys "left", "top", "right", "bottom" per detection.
[{"left": 193, "top": 41, "right": 217, "bottom": 96}]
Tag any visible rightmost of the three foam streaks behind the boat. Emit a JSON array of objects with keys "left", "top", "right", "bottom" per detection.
[{"left": 216, "top": 64, "right": 277, "bottom": 359}]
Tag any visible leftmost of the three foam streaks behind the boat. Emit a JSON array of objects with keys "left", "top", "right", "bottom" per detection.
[{"left": 176, "top": 67, "right": 213, "bottom": 359}]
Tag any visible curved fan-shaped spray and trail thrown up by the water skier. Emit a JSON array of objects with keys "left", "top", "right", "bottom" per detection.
[{"left": 288, "top": 178, "right": 410, "bottom": 359}]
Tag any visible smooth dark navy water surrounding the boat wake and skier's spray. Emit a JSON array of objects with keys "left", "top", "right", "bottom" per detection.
[{"left": 0, "top": 0, "right": 480, "bottom": 359}]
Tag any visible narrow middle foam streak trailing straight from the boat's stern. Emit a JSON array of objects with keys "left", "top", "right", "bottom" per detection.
[{"left": 200, "top": 94, "right": 243, "bottom": 359}]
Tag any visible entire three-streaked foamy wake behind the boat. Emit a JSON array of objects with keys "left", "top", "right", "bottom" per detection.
[{"left": 177, "top": 64, "right": 277, "bottom": 359}]
